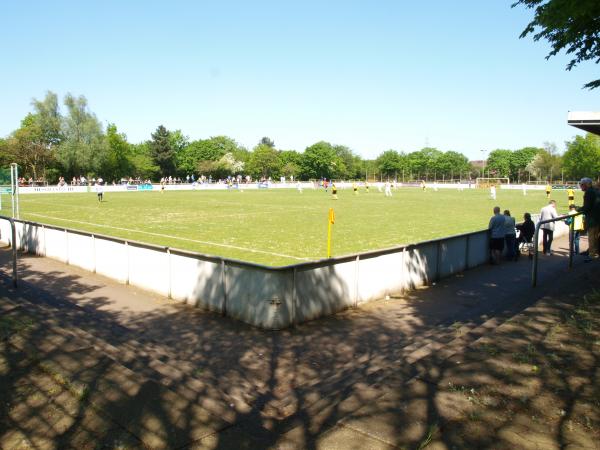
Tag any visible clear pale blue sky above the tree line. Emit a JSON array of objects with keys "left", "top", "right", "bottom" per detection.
[{"left": 0, "top": 0, "right": 600, "bottom": 159}]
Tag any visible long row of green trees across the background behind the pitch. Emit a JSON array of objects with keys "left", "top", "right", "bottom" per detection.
[{"left": 0, "top": 92, "right": 600, "bottom": 183}]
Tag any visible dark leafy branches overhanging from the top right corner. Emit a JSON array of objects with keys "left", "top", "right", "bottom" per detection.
[{"left": 512, "top": 0, "right": 600, "bottom": 89}]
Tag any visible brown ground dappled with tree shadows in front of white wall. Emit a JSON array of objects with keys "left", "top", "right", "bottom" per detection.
[{"left": 0, "top": 244, "right": 600, "bottom": 449}]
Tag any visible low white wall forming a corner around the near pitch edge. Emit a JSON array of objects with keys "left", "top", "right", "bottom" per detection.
[{"left": 0, "top": 217, "right": 568, "bottom": 329}]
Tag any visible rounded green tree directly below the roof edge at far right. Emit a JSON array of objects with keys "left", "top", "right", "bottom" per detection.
[{"left": 563, "top": 133, "right": 600, "bottom": 180}]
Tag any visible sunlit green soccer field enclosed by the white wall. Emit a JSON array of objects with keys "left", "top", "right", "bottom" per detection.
[{"left": 12, "top": 188, "right": 581, "bottom": 266}]
